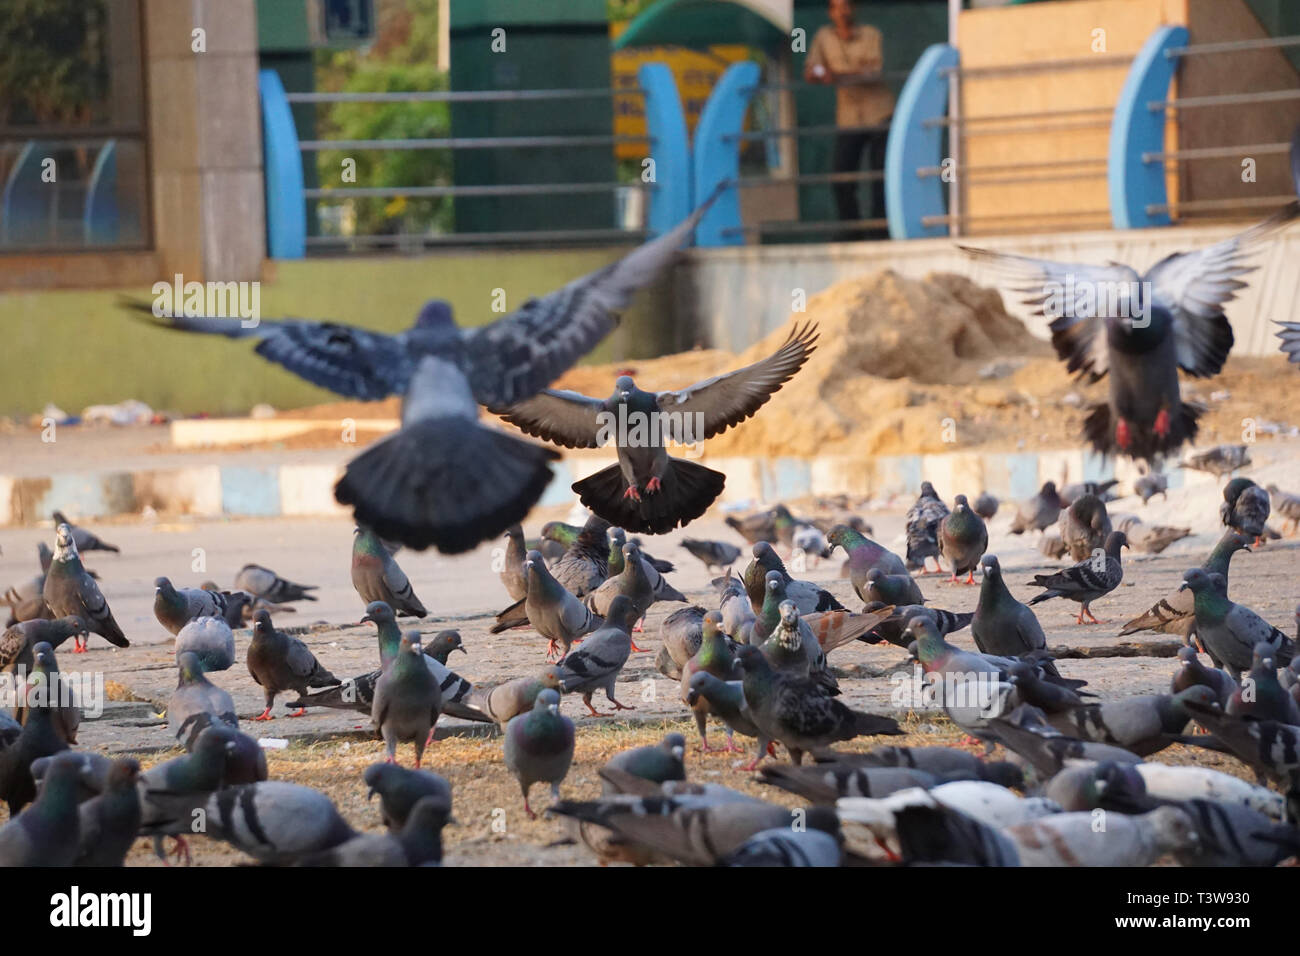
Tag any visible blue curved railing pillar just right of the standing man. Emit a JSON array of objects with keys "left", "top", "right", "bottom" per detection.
[{"left": 885, "top": 43, "right": 959, "bottom": 239}]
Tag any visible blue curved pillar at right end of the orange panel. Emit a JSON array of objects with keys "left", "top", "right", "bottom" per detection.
[{"left": 1106, "top": 26, "right": 1188, "bottom": 229}]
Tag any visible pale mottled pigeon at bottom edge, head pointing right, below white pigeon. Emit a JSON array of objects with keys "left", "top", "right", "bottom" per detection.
[{"left": 1002, "top": 806, "right": 1200, "bottom": 866}]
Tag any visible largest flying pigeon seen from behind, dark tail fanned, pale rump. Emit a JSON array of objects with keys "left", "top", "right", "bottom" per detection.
[{"left": 133, "top": 203, "right": 709, "bottom": 554}]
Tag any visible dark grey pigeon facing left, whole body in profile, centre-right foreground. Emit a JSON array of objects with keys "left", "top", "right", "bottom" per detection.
[{"left": 737, "top": 645, "right": 902, "bottom": 770}]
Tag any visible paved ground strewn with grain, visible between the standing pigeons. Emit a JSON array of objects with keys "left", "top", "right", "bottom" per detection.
[{"left": 0, "top": 481, "right": 1300, "bottom": 864}]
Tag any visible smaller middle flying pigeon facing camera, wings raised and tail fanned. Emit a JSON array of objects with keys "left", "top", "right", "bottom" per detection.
[{"left": 491, "top": 324, "right": 816, "bottom": 535}]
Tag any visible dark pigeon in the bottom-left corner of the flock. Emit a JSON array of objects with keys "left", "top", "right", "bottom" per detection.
[{"left": 0, "top": 754, "right": 82, "bottom": 866}]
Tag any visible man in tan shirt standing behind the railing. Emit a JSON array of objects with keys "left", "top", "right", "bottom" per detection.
[{"left": 803, "top": 0, "right": 894, "bottom": 238}]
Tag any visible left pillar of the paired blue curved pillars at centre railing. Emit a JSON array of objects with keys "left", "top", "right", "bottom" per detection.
[{"left": 637, "top": 62, "right": 696, "bottom": 235}]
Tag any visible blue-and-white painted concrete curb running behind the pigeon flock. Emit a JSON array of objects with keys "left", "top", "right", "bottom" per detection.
[{"left": 0, "top": 450, "right": 1185, "bottom": 525}]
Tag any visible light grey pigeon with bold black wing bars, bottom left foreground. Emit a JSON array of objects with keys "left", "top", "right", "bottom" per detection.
[{"left": 143, "top": 780, "right": 356, "bottom": 865}]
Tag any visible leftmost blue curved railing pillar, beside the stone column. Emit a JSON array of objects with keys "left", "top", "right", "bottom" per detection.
[{"left": 257, "top": 70, "right": 307, "bottom": 259}]
